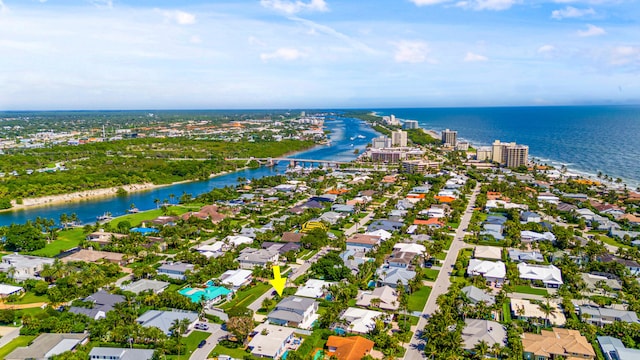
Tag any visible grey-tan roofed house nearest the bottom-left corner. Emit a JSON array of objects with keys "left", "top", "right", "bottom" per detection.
[{"left": 4, "top": 333, "right": 89, "bottom": 360}]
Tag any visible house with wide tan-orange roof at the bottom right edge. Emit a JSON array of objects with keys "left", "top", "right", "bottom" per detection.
[{"left": 522, "top": 328, "right": 596, "bottom": 360}]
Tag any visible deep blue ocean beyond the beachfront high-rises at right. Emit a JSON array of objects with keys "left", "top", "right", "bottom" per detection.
[{"left": 374, "top": 105, "right": 640, "bottom": 189}]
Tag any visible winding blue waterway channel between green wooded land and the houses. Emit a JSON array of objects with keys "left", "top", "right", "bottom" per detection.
[{"left": 0, "top": 117, "right": 378, "bottom": 226}]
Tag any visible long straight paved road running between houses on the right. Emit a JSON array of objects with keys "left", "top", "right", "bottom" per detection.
[{"left": 404, "top": 184, "right": 480, "bottom": 360}]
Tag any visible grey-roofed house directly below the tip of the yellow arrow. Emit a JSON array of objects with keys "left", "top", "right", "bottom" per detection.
[{"left": 267, "top": 296, "right": 318, "bottom": 329}]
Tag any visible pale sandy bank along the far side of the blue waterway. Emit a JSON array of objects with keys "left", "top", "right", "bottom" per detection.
[{"left": 0, "top": 166, "right": 242, "bottom": 212}]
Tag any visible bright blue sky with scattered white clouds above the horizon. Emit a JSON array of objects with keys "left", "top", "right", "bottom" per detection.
[{"left": 0, "top": 0, "right": 640, "bottom": 110}]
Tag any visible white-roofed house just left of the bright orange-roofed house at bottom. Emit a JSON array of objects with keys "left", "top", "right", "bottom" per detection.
[{"left": 247, "top": 323, "right": 294, "bottom": 359}]
